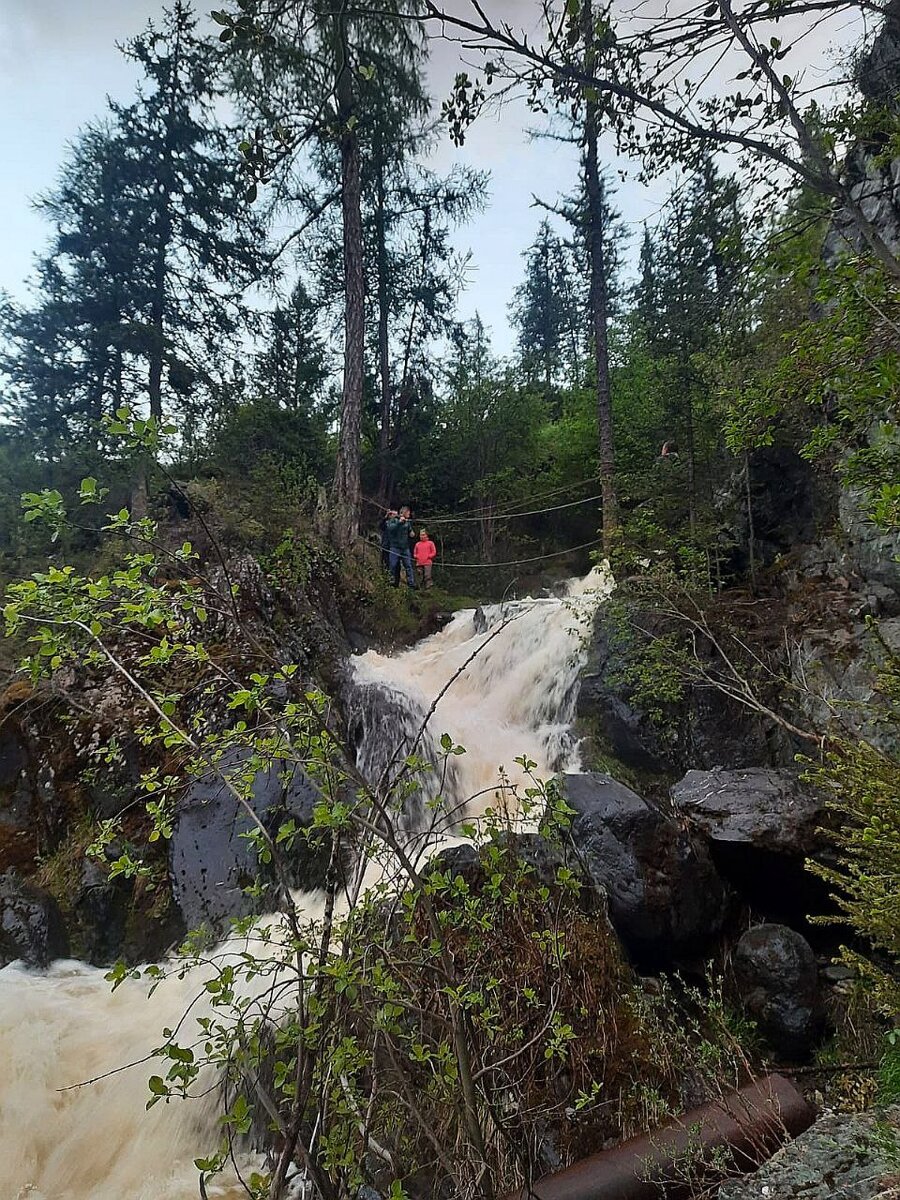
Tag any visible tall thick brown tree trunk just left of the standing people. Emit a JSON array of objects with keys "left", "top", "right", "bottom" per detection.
[{"left": 332, "top": 0, "right": 366, "bottom": 548}]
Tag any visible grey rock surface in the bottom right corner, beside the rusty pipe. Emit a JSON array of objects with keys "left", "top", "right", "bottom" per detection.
[{"left": 719, "top": 1109, "right": 900, "bottom": 1200}]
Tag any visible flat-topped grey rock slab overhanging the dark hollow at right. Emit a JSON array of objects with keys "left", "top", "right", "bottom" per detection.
[{"left": 672, "top": 767, "right": 824, "bottom": 858}]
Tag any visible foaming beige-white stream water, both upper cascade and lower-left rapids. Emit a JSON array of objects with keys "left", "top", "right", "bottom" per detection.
[{"left": 0, "top": 570, "right": 611, "bottom": 1200}]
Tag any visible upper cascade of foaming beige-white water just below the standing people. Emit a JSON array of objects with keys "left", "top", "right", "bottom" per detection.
[{"left": 348, "top": 568, "right": 611, "bottom": 827}]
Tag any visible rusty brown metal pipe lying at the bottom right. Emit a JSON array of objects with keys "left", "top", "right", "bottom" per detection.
[{"left": 504, "top": 1075, "right": 815, "bottom": 1200}]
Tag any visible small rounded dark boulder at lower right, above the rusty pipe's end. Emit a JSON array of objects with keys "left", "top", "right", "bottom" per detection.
[{"left": 733, "top": 925, "right": 822, "bottom": 1060}]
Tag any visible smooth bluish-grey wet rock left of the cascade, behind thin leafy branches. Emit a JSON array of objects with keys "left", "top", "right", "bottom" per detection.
[{"left": 169, "top": 757, "right": 325, "bottom": 929}]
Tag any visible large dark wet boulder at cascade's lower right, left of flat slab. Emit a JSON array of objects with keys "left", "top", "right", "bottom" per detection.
[{"left": 562, "top": 772, "right": 726, "bottom": 966}]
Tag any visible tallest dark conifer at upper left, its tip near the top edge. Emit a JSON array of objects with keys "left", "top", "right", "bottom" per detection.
[{"left": 120, "top": 0, "right": 264, "bottom": 432}]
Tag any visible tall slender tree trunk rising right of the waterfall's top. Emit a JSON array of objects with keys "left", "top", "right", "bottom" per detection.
[{"left": 582, "top": 0, "right": 619, "bottom": 554}]
